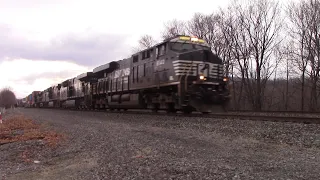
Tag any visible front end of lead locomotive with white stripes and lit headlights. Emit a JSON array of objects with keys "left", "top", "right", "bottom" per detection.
[{"left": 169, "top": 36, "right": 229, "bottom": 113}]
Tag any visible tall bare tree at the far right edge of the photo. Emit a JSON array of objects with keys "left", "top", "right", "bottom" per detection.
[{"left": 288, "top": 0, "right": 320, "bottom": 111}]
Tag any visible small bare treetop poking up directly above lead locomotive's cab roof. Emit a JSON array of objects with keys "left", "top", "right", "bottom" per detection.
[{"left": 162, "top": 19, "right": 187, "bottom": 39}]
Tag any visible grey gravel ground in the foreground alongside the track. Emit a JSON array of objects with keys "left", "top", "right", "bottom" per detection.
[{"left": 0, "top": 108, "right": 320, "bottom": 180}]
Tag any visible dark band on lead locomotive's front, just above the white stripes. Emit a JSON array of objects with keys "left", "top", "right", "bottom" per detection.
[{"left": 179, "top": 50, "right": 222, "bottom": 63}]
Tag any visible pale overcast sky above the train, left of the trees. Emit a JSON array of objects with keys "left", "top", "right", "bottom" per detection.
[{"left": 0, "top": 0, "right": 294, "bottom": 98}]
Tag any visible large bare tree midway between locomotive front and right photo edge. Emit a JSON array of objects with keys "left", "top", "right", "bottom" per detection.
[{"left": 238, "top": 0, "right": 281, "bottom": 111}]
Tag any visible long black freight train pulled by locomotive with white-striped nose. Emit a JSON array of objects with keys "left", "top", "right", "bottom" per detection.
[{"left": 21, "top": 35, "right": 230, "bottom": 113}]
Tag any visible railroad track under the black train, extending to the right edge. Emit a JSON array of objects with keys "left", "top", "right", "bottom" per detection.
[{"left": 18, "top": 108, "right": 320, "bottom": 124}]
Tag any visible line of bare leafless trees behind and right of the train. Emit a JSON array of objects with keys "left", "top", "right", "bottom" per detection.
[{"left": 133, "top": 0, "right": 320, "bottom": 111}]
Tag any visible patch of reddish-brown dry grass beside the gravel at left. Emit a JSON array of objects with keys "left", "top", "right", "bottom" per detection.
[{"left": 0, "top": 116, "right": 64, "bottom": 147}]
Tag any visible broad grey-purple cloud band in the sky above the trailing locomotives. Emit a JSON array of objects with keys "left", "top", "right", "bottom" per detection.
[{"left": 0, "top": 24, "right": 130, "bottom": 66}]
